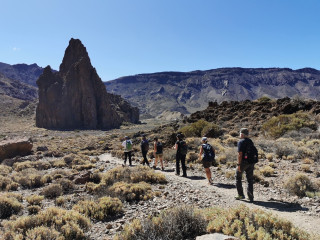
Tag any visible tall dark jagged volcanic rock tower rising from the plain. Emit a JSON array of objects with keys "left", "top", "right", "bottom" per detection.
[{"left": 36, "top": 38, "right": 139, "bottom": 129}]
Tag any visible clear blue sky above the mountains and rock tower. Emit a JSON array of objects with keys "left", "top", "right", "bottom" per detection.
[{"left": 0, "top": 0, "right": 320, "bottom": 81}]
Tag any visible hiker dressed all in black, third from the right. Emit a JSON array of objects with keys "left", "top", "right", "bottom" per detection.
[{"left": 173, "top": 133, "right": 188, "bottom": 177}]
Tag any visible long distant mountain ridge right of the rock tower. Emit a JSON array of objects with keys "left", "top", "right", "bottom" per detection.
[{"left": 105, "top": 68, "right": 320, "bottom": 117}]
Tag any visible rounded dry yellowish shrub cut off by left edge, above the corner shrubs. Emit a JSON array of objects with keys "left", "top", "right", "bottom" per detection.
[{"left": 0, "top": 196, "right": 23, "bottom": 219}]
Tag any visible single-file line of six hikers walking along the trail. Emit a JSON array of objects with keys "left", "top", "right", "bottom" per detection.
[{"left": 122, "top": 128, "right": 258, "bottom": 202}]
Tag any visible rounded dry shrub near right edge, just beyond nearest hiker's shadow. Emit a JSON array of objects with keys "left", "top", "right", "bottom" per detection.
[{"left": 285, "top": 173, "right": 315, "bottom": 198}]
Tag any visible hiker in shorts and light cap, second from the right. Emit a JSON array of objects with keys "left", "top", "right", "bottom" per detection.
[{"left": 199, "top": 137, "right": 215, "bottom": 185}]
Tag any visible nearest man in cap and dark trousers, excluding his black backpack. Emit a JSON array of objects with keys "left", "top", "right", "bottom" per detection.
[{"left": 236, "top": 128, "right": 255, "bottom": 202}]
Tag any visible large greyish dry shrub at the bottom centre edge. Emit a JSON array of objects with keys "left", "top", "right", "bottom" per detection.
[{"left": 114, "top": 206, "right": 207, "bottom": 240}]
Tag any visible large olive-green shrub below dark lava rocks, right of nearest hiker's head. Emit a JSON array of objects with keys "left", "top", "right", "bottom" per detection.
[{"left": 261, "top": 112, "right": 317, "bottom": 138}]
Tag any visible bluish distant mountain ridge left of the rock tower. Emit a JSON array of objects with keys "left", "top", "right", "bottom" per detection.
[{"left": 0, "top": 62, "right": 43, "bottom": 86}]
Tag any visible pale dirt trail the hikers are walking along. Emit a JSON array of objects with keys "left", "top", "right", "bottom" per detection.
[{"left": 100, "top": 154, "right": 320, "bottom": 234}]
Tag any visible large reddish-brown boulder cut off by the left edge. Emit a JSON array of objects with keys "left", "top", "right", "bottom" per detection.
[{"left": 0, "top": 138, "right": 33, "bottom": 161}]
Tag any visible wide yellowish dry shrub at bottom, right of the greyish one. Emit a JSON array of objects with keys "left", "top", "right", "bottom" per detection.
[{"left": 203, "top": 205, "right": 310, "bottom": 240}]
